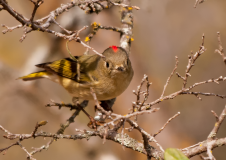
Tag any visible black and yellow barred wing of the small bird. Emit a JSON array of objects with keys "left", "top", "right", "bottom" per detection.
[{"left": 36, "top": 56, "right": 91, "bottom": 83}]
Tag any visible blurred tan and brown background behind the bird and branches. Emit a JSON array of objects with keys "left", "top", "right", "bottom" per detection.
[{"left": 0, "top": 0, "right": 226, "bottom": 160}]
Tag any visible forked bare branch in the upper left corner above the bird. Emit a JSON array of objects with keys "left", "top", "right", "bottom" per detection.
[{"left": 0, "top": 0, "right": 128, "bottom": 43}]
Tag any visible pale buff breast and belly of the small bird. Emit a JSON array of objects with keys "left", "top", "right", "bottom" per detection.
[{"left": 57, "top": 70, "right": 132, "bottom": 100}]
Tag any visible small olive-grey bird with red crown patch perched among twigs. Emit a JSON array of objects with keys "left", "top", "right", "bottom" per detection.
[{"left": 19, "top": 46, "right": 133, "bottom": 100}]
